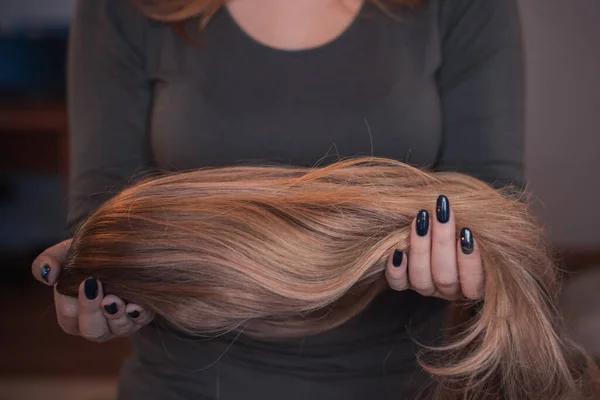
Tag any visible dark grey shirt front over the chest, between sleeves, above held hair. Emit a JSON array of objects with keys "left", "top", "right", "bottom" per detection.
[{"left": 149, "top": 3, "right": 442, "bottom": 169}]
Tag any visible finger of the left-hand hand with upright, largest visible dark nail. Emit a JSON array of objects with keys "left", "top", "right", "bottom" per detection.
[{"left": 79, "top": 278, "right": 111, "bottom": 342}]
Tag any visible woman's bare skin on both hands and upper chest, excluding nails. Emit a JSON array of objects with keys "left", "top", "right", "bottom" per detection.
[{"left": 32, "top": 0, "right": 484, "bottom": 342}]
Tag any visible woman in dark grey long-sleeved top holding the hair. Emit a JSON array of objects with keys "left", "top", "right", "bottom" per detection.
[{"left": 33, "top": 0, "right": 523, "bottom": 400}]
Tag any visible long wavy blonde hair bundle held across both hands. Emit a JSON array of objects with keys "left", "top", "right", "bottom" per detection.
[{"left": 58, "top": 158, "right": 598, "bottom": 400}]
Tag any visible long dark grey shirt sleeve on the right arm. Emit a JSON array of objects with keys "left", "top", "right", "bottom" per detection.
[{"left": 437, "top": 0, "right": 524, "bottom": 186}]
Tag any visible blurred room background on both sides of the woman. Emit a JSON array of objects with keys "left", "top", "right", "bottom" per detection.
[{"left": 0, "top": 0, "right": 600, "bottom": 400}]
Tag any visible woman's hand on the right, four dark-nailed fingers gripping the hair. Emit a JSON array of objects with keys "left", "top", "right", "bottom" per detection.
[{"left": 386, "top": 196, "right": 485, "bottom": 300}]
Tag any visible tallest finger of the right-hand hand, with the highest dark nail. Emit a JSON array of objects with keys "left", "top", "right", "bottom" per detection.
[{"left": 431, "top": 196, "right": 460, "bottom": 299}]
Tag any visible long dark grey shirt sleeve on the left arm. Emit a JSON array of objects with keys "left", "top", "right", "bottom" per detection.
[{"left": 67, "top": 0, "right": 152, "bottom": 234}]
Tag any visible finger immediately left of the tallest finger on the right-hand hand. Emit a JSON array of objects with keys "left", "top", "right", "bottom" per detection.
[{"left": 408, "top": 210, "right": 435, "bottom": 296}]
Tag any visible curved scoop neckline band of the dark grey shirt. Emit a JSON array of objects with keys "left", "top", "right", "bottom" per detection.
[{"left": 222, "top": 0, "right": 368, "bottom": 55}]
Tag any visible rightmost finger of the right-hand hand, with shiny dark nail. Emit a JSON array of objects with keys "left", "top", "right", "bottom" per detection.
[{"left": 457, "top": 228, "right": 485, "bottom": 300}]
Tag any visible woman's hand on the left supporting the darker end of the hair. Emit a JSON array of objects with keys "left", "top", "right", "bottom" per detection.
[{"left": 31, "top": 240, "right": 153, "bottom": 342}]
